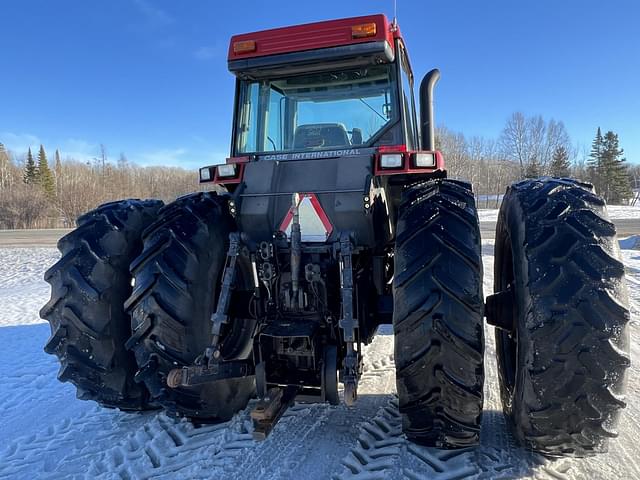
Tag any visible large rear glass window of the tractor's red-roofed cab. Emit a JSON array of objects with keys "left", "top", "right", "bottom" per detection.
[{"left": 236, "top": 65, "right": 398, "bottom": 154}]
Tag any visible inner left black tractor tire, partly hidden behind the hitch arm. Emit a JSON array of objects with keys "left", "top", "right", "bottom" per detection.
[{"left": 127, "top": 192, "right": 255, "bottom": 422}]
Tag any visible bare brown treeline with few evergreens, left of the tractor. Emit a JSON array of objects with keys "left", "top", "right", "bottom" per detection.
[{"left": 0, "top": 143, "right": 200, "bottom": 229}]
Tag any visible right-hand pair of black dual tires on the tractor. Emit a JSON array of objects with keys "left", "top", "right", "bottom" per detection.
[{"left": 394, "top": 178, "right": 630, "bottom": 456}]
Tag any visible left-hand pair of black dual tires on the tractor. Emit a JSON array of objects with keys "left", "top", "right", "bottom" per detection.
[{"left": 40, "top": 193, "right": 255, "bottom": 421}]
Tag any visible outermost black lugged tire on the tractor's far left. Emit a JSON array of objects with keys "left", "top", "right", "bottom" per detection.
[{"left": 40, "top": 200, "right": 162, "bottom": 410}]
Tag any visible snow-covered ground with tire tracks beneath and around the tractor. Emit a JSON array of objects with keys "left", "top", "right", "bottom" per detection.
[{"left": 0, "top": 244, "right": 640, "bottom": 480}]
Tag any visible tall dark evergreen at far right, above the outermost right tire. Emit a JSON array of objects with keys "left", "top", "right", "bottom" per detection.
[{"left": 599, "top": 131, "right": 632, "bottom": 204}]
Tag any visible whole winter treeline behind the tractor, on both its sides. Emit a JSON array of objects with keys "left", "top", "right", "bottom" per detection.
[{"left": 0, "top": 113, "right": 640, "bottom": 229}]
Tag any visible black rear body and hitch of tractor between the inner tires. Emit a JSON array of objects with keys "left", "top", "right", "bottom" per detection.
[{"left": 200, "top": 154, "right": 446, "bottom": 403}]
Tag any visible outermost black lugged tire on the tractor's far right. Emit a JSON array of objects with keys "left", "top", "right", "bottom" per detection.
[{"left": 494, "top": 178, "right": 629, "bottom": 456}]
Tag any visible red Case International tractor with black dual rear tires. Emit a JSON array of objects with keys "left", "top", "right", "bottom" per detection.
[{"left": 41, "top": 15, "right": 629, "bottom": 455}]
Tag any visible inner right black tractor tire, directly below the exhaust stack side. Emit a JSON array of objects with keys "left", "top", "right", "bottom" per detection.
[{"left": 393, "top": 180, "right": 484, "bottom": 448}]
